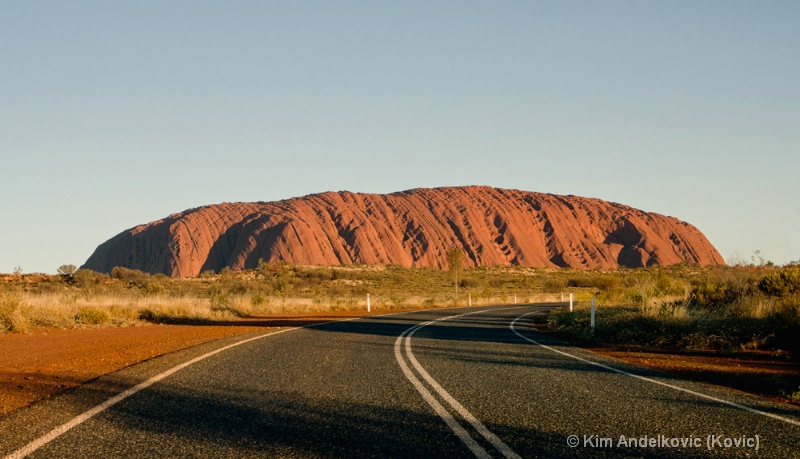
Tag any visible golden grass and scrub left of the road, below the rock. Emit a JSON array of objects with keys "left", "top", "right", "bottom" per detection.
[{"left": 0, "top": 263, "right": 556, "bottom": 332}]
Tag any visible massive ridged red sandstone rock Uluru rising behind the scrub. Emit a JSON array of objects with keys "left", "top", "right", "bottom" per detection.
[{"left": 82, "top": 186, "right": 724, "bottom": 277}]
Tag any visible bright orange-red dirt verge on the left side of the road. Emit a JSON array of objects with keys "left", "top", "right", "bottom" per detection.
[{"left": 0, "top": 311, "right": 372, "bottom": 416}]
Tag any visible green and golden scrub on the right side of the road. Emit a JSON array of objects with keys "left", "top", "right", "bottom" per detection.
[{"left": 549, "top": 266, "right": 800, "bottom": 357}]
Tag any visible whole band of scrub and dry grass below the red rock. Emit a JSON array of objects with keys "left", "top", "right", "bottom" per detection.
[{"left": 0, "top": 263, "right": 800, "bottom": 356}]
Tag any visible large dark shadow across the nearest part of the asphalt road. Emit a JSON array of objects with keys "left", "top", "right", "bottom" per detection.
[{"left": 18, "top": 374, "right": 690, "bottom": 458}]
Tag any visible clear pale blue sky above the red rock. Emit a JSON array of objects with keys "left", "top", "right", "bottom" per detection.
[{"left": 0, "top": 0, "right": 800, "bottom": 273}]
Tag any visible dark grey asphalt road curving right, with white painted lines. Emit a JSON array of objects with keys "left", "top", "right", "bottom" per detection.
[{"left": 0, "top": 305, "right": 800, "bottom": 458}]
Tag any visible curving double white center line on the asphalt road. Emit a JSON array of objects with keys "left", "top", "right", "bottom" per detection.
[{"left": 394, "top": 310, "right": 520, "bottom": 458}]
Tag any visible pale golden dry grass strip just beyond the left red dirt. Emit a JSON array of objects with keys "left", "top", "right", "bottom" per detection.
[{"left": 0, "top": 292, "right": 572, "bottom": 333}]
